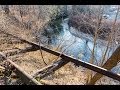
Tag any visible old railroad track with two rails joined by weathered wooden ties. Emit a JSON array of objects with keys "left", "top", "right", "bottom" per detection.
[{"left": 0, "top": 31, "right": 120, "bottom": 85}]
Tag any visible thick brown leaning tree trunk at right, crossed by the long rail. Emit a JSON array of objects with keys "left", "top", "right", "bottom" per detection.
[{"left": 88, "top": 46, "right": 120, "bottom": 85}]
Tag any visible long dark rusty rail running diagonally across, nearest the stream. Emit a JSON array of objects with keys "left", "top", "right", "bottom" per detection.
[{"left": 2, "top": 31, "right": 120, "bottom": 81}]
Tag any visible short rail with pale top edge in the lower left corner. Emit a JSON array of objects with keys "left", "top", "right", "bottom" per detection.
[{"left": 7, "top": 60, "right": 42, "bottom": 85}]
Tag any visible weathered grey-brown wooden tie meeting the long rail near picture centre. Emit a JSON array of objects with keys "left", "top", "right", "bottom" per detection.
[{"left": 33, "top": 59, "right": 69, "bottom": 79}]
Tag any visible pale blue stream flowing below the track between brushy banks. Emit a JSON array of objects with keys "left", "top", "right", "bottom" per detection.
[{"left": 41, "top": 18, "right": 113, "bottom": 62}]
